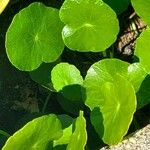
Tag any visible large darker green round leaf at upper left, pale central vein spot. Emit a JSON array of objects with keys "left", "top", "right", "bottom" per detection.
[{"left": 6, "top": 2, "right": 64, "bottom": 71}]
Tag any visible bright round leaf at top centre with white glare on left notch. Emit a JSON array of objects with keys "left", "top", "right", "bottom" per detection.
[{"left": 60, "top": 0, "right": 119, "bottom": 52}]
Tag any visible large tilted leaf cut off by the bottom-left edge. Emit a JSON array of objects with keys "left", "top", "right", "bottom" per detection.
[{"left": 2, "top": 115, "right": 62, "bottom": 150}]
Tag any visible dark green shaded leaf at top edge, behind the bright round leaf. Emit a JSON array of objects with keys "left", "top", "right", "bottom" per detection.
[{"left": 103, "top": 0, "right": 131, "bottom": 14}]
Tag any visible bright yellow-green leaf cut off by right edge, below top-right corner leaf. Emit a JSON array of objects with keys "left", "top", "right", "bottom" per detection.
[{"left": 135, "top": 28, "right": 150, "bottom": 73}]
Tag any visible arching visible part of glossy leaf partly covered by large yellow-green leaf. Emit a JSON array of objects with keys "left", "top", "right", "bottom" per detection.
[{"left": 84, "top": 59, "right": 129, "bottom": 109}]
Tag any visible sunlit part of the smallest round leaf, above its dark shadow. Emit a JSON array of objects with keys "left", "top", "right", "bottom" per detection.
[{"left": 51, "top": 63, "right": 83, "bottom": 91}]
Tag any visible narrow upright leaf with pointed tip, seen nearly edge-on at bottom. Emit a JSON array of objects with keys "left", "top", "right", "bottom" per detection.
[{"left": 66, "top": 111, "right": 87, "bottom": 150}]
